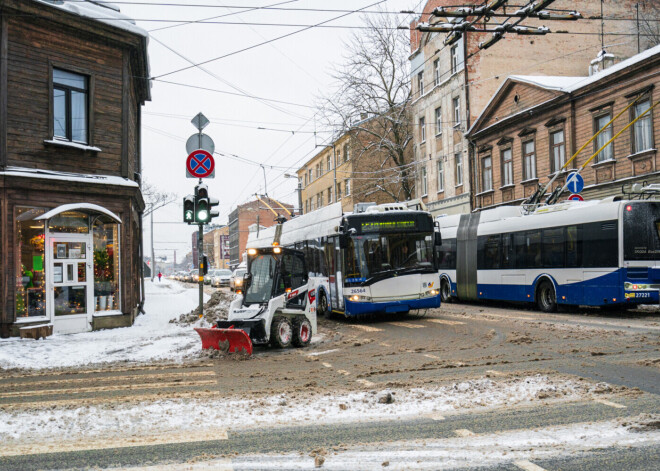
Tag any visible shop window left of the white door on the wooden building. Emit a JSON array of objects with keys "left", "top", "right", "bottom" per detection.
[{"left": 14, "top": 206, "right": 46, "bottom": 319}]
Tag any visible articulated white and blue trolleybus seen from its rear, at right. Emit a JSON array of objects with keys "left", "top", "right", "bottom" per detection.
[{"left": 437, "top": 195, "right": 660, "bottom": 312}]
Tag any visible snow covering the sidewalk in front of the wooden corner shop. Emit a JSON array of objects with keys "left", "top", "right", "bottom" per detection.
[{"left": 0, "top": 278, "right": 208, "bottom": 370}]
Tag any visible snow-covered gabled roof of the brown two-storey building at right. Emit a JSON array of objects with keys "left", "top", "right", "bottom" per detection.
[{"left": 465, "top": 45, "right": 660, "bottom": 136}]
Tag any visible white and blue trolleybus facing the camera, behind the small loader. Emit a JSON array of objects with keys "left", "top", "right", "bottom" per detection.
[{"left": 248, "top": 203, "right": 440, "bottom": 317}]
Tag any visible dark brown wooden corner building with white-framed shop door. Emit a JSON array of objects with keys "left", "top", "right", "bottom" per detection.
[{"left": 0, "top": 0, "right": 150, "bottom": 337}]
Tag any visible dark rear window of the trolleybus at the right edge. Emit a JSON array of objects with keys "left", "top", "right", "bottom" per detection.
[{"left": 623, "top": 201, "right": 660, "bottom": 260}]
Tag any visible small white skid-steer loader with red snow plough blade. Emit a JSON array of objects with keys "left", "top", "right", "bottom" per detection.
[{"left": 195, "top": 246, "right": 317, "bottom": 355}]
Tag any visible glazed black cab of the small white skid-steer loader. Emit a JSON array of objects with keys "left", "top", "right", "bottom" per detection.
[{"left": 243, "top": 247, "right": 307, "bottom": 306}]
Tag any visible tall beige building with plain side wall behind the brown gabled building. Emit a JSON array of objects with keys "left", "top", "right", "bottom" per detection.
[{"left": 410, "top": 0, "right": 645, "bottom": 214}]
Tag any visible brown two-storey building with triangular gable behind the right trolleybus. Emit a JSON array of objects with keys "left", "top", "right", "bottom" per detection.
[{"left": 468, "top": 46, "right": 660, "bottom": 209}]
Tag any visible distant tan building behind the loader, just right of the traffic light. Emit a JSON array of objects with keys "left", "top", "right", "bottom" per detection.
[{"left": 227, "top": 197, "right": 293, "bottom": 269}]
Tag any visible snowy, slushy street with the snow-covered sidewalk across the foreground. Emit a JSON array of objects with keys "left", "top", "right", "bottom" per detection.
[{"left": 0, "top": 279, "right": 660, "bottom": 471}]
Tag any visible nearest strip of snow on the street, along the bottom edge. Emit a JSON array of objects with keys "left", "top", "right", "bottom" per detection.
[{"left": 215, "top": 419, "right": 660, "bottom": 471}]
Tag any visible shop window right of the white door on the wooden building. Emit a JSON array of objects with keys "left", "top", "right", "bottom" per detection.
[{"left": 93, "top": 220, "right": 120, "bottom": 311}]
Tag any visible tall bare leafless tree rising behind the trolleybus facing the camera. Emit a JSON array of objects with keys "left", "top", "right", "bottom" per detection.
[{"left": 321, "top": 14, "right": 415, "bottom": 201}]
